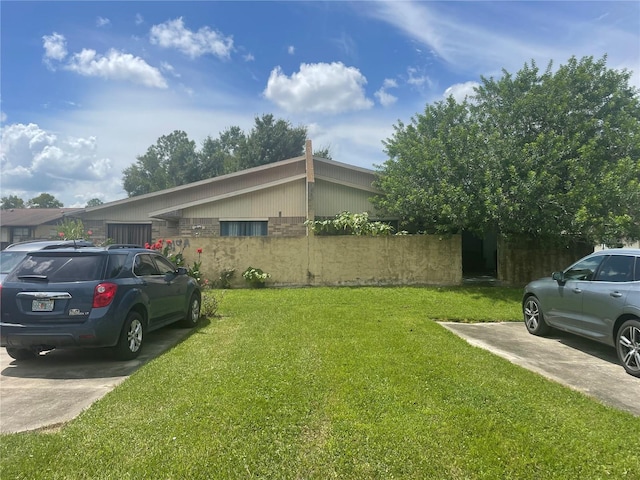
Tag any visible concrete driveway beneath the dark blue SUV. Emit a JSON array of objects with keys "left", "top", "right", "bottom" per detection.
[{"left": 0, "top": 326, "right": 192, "bottom": 433}]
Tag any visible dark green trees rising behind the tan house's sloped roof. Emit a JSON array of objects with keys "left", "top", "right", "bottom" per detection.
[{"left": 123, "top": 114, "right": 312, "bottom": 197}]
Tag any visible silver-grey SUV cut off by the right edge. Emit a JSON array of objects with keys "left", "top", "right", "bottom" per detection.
[{"left": 522, "top": 248, "right": 640, "bottom": 377}]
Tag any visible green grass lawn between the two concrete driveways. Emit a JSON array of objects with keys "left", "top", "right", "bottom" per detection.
[{"left": 0, "top": 287, "right": 640, "bottom": 480}]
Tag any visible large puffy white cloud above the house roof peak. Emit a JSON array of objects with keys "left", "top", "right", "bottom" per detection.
[{"left": 263, "top": 62, "right": 373, "bottom": 114}]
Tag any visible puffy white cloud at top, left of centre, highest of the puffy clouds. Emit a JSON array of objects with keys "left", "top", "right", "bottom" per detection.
[{"left": 150, "top": 17, "right": 233, "bottom": 59}]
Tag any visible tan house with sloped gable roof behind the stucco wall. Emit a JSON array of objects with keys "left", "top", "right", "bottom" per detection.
[{"left": 71, "top": 141, "right": 390, "bottom": 245}]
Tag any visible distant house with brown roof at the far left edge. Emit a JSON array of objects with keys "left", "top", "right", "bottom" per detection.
[{"left": 0, "top": 208, "right": 82, "bottom": 249}]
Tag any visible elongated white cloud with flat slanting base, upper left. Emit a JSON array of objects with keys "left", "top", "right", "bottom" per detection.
[{"left": 64, "top": 49, "right": 167, "bottom": 88}]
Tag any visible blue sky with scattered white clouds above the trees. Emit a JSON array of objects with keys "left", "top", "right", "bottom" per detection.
[{"left": 0, "top": 0, "right": 640, "bottom": 207}]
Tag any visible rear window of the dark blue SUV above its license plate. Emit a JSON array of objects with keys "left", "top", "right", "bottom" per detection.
[{"left": 8, "top": 254, "right": 104, "bottom": 282}]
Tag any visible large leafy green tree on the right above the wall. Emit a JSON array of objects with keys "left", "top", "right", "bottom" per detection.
[{"left": 378, "top": 57, "right": 640, "bottom": 244}]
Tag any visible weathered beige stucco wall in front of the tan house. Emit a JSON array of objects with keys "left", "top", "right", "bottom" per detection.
[{"left": 169, "top": 235, "right": 462, "bottom": 288}]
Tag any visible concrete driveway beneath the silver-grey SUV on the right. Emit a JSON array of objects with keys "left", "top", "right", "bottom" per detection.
[{"left": 441, "top": 322, "right": 640, "bottom": 416}]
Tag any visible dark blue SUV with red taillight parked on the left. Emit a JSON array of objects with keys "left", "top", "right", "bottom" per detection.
[{"left": 0, "top": 245, "right": 201, "bottom": 360}]
